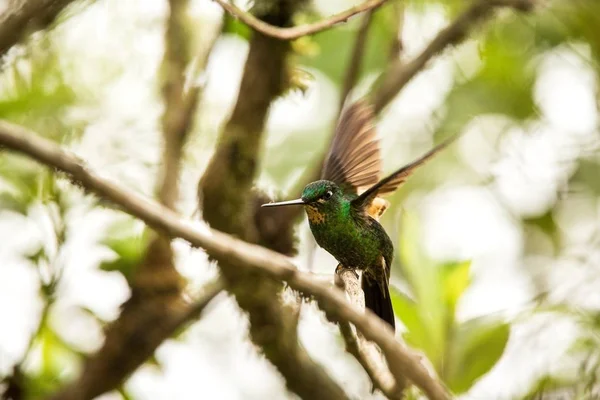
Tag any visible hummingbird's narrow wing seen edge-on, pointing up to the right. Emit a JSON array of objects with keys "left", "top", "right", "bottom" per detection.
[{"left": 352, "top": 136, "right": 456, "bottom": 209}]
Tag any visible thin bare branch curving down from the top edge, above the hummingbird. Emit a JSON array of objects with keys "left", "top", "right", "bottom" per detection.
[{"left": 214, "top": 0, "right": 387, "bottom": 40}]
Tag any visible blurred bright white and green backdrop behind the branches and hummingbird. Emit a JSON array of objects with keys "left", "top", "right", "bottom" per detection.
[{"left": 0, "top": 0, "right": 600, "bottom": 400}]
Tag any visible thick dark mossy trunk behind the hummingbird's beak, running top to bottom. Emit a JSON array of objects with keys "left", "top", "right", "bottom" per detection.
[{"left": 199, "top": 0, "right": 347, "bottom": 400}]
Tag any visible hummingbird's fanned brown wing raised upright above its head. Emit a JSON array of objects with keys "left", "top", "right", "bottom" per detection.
[{"left": 321, "top": 101, "right": 381, "bottom": 194}]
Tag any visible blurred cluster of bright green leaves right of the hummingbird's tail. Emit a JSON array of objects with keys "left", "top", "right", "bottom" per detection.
[{"left": 391, "top": 213, "right": 510, "bottom": 394}]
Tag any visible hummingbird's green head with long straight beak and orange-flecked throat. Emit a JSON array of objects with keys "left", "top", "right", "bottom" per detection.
[{"left": 262, "top": 180, "right": 344, "bottom": 223}]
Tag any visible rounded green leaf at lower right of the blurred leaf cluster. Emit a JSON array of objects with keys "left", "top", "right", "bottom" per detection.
[{"left": 442, "top": 317, "right": 510, "bottom": 394}]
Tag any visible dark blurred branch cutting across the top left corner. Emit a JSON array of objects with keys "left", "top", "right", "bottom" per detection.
[{"left": 0, "top": 0, "right": 81, "bottom": 55}]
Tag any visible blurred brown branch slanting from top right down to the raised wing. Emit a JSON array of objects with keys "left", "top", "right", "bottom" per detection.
[{"left": 371, "top": 0, "right": 535, "bottom": 113}]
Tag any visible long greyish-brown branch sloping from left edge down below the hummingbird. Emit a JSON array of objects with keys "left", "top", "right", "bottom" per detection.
[{"left": 0, "top": 121, "right": 450, "bottom": 400}]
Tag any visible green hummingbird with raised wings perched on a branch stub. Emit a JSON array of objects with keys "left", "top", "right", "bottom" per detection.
[{"left": 262, "top": 100, "right": 452, "bottom": 330}]
